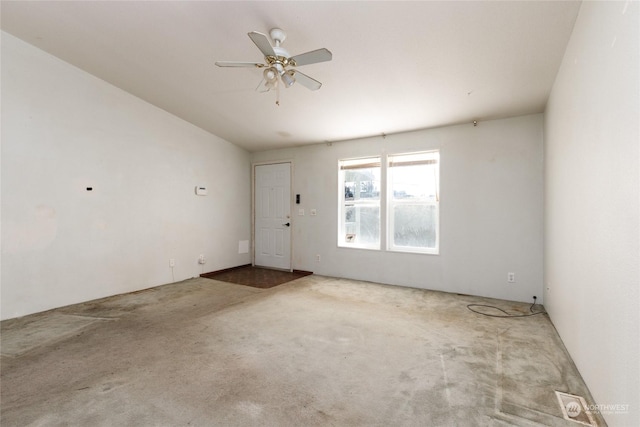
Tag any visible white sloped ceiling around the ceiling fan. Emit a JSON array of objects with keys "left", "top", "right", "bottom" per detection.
[{"left": 1, "top": 1, "right": 580, "bottom": 151}]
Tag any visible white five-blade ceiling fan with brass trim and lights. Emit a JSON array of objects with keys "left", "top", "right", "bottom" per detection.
[{"left": 216, "top": 28, "right": 332, "bottom": 105}]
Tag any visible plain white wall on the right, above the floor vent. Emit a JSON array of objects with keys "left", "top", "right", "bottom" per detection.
[{"left": 545, "top": 2, "right": 640, "bottom": 426}]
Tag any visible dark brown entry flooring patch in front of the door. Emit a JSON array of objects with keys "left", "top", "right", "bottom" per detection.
[{"left": 200, "top": 265, "right": 313, "bottom": 289}]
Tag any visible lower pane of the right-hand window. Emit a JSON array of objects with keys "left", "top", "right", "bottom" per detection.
[{"left": 393, "top": 203, "right": 438, "bottom": 248}]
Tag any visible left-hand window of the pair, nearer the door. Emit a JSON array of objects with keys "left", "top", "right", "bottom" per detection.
[{"left": 338, "top": 157, "right": 381, "bottom": 249}]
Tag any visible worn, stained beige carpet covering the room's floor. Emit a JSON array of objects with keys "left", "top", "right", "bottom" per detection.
[{"left": 0, "top": 275, "right": 602, "bottom": 427}]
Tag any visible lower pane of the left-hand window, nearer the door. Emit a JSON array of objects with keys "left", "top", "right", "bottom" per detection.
[{"left": 343, "top": 205, "right": 380, "bottom": 246}]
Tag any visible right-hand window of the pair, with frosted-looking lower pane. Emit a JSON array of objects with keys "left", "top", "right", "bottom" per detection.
[{"left": 387, "top": 151, "right": 439, "bottom": 253}]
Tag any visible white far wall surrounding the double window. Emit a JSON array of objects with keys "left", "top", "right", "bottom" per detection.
[{"left": 253, "top": 115, "right": 543, "bottom": 302}]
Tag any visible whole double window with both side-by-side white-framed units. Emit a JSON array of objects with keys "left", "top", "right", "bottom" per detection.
[{"left": 338, "top": 151, "right": 439, "bottom": 254}]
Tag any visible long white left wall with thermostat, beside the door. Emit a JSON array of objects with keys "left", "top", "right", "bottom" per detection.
[{"left": 1, "top": 33, "right": 251, "bottom": 318}]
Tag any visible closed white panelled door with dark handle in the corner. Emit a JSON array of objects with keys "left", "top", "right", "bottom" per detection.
[{"left": 254, "top": 163, "right": 291, "bottom": 270}]
